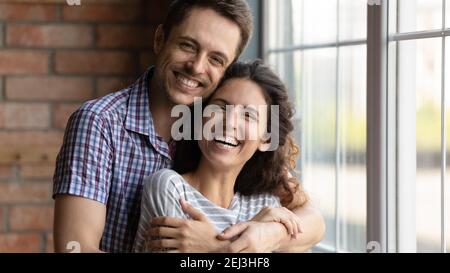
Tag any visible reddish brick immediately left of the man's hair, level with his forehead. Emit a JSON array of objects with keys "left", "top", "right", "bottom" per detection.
[{"left": 97, "top": 26, "right": 155, "bottom": 48}]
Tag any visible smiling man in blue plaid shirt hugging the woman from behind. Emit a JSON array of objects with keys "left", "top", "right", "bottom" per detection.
[{"left": 54, "top": 0, "right": 324, "bottom": 252}]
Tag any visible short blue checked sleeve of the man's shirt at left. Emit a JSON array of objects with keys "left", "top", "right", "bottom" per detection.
[{"left": 53, "top": 109, "right": 112, "bottom": 204}]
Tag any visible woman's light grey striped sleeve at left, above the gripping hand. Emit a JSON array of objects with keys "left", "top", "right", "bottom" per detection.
[{"left": 133, "top": 170, "right": 188, "bottom": 252}]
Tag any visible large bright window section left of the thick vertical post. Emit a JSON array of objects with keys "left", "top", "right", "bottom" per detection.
[{"left": 265, "top": 0, "right": 367, "bottom": 252}]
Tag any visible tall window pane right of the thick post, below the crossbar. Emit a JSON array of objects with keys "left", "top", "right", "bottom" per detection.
[{"left": 399, "top": 38, "right": 442, "bottom": 252}]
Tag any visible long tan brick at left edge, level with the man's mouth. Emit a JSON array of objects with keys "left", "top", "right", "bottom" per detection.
[{"left": 5, "top": 76, "right": 94, "bottom": 101}]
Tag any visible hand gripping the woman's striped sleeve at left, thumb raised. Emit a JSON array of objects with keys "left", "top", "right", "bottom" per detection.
[{"left": 146, "top": 200, "right": 229, "bottom": 252}]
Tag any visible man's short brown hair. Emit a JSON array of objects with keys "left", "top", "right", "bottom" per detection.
[{"left": 163, "top": 0, "right": 253, "bottom": 59}]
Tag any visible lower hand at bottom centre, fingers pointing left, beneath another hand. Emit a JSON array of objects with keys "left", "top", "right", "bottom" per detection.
[{"left": 218, "top": 221, "right": 287, "bottom": 253}]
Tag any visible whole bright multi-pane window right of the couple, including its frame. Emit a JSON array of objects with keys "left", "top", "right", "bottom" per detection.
[{"left": 263, "top": 0, "right": 450, "bottom": 252}]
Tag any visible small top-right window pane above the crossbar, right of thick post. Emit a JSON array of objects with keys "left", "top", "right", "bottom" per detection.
[{"left": 398, "top": 0, "right": 442, "bottom": 32}]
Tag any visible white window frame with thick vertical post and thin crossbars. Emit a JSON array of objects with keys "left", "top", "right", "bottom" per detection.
[{"left": 262, "top": 0, "right": 450, "bottom": 253}]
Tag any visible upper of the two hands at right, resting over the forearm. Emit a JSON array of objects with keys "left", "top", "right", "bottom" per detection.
[{"left": 252, "top": 207, "right": 303, "bottom": 239}]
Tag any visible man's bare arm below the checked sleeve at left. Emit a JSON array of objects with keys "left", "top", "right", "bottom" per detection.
[{"left": 54, "top": 195, "right": 106, "bottom": 252}]
